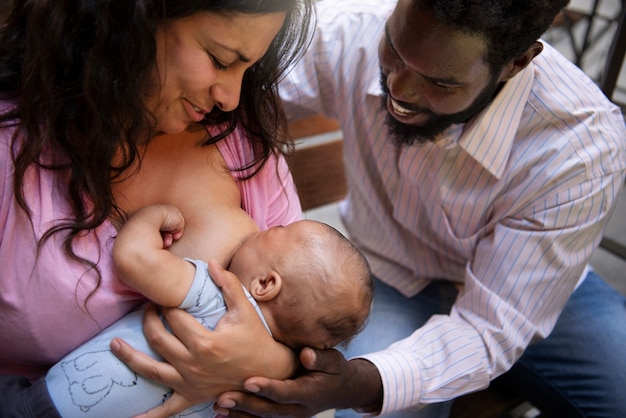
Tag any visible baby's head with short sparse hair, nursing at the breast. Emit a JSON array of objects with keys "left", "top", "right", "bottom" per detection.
[{"left": 230, "top": 220, "right": 374, "bottom": 350}]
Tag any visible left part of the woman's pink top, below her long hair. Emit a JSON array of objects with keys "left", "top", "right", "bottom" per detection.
[{"left": 0, "top": 111, "right": 145, "bottom": 379}]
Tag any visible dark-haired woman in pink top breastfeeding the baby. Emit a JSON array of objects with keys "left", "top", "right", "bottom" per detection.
[{"left": 0, "top": 0, "right": 311, "bottom": 416}]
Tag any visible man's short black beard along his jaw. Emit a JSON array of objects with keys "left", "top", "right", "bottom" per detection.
[{"left": 380, "top": 72, "right": 501, "bottom": 146}]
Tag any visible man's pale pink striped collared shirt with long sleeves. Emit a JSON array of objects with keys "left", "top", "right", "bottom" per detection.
[{"left": 281, "top": 0, "right": 626, "bottom": 414}]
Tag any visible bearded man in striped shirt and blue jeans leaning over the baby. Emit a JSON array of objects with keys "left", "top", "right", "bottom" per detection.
[{"left": 211, "top": 0, "right": 626, "bottom": 417}]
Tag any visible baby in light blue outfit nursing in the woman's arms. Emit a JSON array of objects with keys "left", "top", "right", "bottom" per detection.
[{"left": 46, "top": 205, "right": 373, "bottom": 417}]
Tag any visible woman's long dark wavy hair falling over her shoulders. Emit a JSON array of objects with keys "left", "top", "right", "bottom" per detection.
[{"left": 0, "top": 0, "right": 313, "bottom": 300}]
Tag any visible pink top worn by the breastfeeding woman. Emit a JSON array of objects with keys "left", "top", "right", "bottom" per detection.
[{"left": 0, "top": 102, "right": 302, "bottom": 379}]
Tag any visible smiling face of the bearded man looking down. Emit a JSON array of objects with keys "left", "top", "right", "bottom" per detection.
[{"left": 378, "top": 0, "right": 500, "bottom": 145}]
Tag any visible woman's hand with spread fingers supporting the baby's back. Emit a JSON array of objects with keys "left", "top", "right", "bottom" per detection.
[{"left": 111, "top": 261, "right": 297, "bottom": 417}]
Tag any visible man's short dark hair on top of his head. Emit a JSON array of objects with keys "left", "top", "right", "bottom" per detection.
[{"left": 412, "top": 0, "right": 569, "bottom": 73}]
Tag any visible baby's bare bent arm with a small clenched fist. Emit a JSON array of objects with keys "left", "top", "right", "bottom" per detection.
[{"left": 113, "top": 205, "right": 195, "bottom": 307}]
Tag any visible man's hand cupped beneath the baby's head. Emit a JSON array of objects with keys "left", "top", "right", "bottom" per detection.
[{"left": 214, "top": 348, "right": 383, "bottom": 417}]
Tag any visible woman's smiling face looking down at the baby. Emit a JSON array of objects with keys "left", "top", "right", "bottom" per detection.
[{"left": 147, "top": 12, "right": 285, "bottom": 134}]
